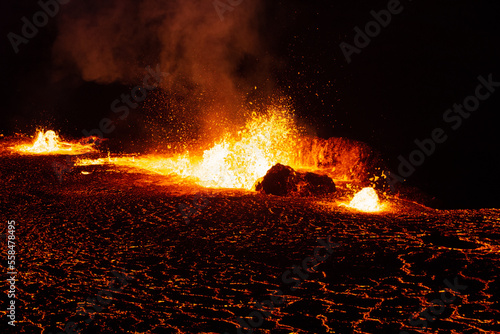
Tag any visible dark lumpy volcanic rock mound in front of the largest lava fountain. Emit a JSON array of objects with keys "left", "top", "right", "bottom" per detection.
[{"left": 255, "top": 164, "right": 335, "bottom": 196}]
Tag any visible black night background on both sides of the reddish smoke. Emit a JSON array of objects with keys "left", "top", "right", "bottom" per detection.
[{"left": 0, "top": 0, "right": 500, "bottom": 208}]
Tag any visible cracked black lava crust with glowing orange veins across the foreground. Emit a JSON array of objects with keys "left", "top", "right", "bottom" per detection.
[{"left": 0, "top": 154, "right": 500, "bottom": 334}]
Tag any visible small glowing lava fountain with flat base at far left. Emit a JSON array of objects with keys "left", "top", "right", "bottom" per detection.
[{"left": 12, "top": 130, "right": 95, "bottom": 154}]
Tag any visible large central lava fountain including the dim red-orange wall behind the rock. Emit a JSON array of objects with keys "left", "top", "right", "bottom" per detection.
[{"left": 77, "top": 108, "right": 376, "bottom": 190}]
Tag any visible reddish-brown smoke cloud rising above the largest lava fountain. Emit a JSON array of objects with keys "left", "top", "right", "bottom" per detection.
[{"left": 53, "top": 0, "right": 269, "bottom": 127}]
